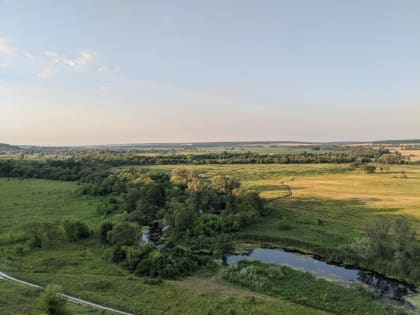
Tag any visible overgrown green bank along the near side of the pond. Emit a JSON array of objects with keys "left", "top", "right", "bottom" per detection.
[{"left": 224, "top": 261, "right": 408, "bottom": 315}]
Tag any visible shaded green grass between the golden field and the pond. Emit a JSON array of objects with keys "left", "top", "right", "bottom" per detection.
[{"left": 238, "top": 197, "right": 410, "bottom": 252}]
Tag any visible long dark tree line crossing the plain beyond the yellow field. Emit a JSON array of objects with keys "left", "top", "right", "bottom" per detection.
[{"left": 0, "top": 147, "right": 408, "bottom": 181}]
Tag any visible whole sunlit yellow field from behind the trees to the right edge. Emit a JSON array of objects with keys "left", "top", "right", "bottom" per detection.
[{"left": 139, "top": 164, "right": 420, "bottom": 223}]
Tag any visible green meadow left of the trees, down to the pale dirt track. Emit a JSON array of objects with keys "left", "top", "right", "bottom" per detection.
[{"left": 0, "top": 178, "right": 325, "bottom": 314}]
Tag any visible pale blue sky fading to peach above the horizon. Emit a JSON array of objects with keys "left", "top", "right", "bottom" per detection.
[{"left": 0, "top": 0, "right": 420, "bottom": 145}]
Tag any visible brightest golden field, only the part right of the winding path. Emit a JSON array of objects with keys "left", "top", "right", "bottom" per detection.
[{"left": 285, "top": 166, "right": 420, "bottom": 218}]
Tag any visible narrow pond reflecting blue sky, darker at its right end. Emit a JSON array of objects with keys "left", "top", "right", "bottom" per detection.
[{"left": 227, "top": 248, "right": 416, "bottom": 308}]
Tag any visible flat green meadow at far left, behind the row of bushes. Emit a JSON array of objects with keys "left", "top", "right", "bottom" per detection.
[{"left": 0, "top": 178, "right": 102, "bottom": 244}]
